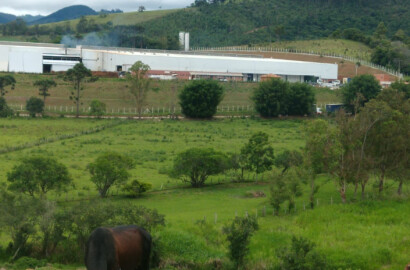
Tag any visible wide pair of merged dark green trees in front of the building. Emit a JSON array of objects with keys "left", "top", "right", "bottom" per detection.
[{"left": 252, "top": 78, "right": 316, "bottom": 117}]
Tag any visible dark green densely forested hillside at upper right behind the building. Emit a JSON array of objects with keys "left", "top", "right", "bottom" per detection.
[{"left": 139, "top": 0, "right": 410, "bottom": 46}]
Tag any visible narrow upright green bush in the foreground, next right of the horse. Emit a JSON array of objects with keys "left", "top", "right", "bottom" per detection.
[{"left": 223, "top": 216, "right": 258, "bottom": 268}]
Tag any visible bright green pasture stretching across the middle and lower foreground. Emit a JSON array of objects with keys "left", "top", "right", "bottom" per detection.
[{"left": 0, "top": 118, "right": 410, "bottom": 270}]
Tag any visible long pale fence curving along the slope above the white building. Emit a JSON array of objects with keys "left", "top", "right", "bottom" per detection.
[{"left": 191, "top": 46, "right": 403, "bottom": 78}]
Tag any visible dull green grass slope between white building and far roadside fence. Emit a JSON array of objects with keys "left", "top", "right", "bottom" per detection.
[{"left": 0, "top": 73, "right": 340, "bottom": 114}]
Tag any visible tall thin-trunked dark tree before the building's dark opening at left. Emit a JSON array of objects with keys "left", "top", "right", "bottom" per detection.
[{"left": 64, "top": 63, "right": 94, "bottom": 118}]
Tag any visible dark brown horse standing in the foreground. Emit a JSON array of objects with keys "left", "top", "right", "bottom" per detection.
[{"left": 85, "top": 225, "right": 152, "bottom": 270}]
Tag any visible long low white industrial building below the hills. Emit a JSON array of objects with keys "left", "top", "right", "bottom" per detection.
[{"left": 0, "top": 42, "right": 338, "bottom": 82}]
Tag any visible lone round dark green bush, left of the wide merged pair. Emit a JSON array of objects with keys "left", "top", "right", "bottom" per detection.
[{"left": 179, "top": 80, "right": 224, "bottom": 118}]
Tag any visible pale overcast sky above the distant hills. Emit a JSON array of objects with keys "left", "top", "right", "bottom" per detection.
[{"left": 0, "top": 0, "right": 194, "bottom": 15}]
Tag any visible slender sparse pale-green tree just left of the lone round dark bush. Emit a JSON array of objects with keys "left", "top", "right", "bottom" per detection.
[{"left": 126, "top": 61, "right": 151, "bottom": 118}]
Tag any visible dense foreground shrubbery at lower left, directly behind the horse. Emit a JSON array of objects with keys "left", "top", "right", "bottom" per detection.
[{"left": 0, "top": 192, "right": 165, "bottom": 263}]
